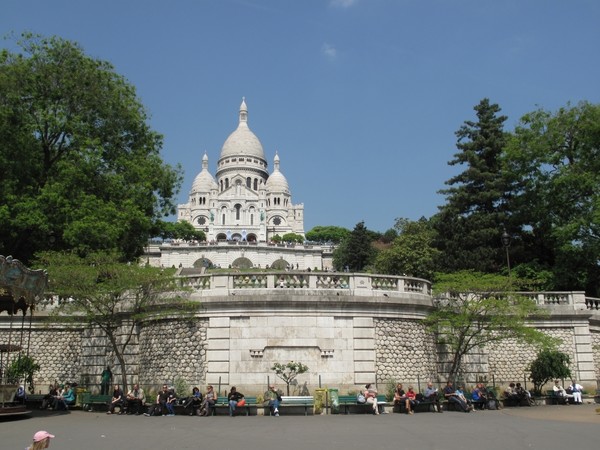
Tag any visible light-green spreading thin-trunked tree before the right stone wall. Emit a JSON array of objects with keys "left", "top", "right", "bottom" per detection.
[{"left": 425, "top": 271, "right": 556, "bottom": 381}]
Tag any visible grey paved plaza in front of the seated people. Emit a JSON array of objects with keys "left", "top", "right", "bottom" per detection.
[{"left": 0, "top": 404, "right": 600, "bottom": 450}]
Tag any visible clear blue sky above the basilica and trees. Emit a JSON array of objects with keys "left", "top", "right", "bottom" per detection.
[{"left": 0, "top": 0, "right": 600, "bottom": 232}]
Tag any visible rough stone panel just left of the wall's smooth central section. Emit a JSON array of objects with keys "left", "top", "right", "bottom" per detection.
[{"left": 139, "top": 319, "right": 208, "bottom": 387}]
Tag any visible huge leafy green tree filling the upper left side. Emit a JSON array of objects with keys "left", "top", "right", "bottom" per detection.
[{"left": 0, "top": 34, "right": 181, "bottom": 262}]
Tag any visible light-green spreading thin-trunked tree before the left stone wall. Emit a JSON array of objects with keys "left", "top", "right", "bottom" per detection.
[{"left": 37, "top": 252, "right": 198, "bottom": 391}]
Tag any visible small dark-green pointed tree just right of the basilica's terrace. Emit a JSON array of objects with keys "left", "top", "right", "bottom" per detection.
[{"left": 333, "top": 222, "right": 376, "bottom": 272}]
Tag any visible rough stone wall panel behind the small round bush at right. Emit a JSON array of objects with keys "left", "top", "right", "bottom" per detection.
[{"left": 488, "top": 328, "right": 577, "bottom": 386}]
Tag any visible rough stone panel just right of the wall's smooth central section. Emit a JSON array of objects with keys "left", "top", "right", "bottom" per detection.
[{"left": 375, "top": 319, "right": 437, "bottom": 388}]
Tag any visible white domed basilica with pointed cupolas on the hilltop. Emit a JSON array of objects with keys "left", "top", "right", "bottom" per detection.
[{"left": 177, "top": 101, "right": 304, "bottom": 246}]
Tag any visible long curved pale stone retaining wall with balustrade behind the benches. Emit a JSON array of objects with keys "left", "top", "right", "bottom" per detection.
[{"left": 0, "top": 272, "right": 600, "bottom": 395}]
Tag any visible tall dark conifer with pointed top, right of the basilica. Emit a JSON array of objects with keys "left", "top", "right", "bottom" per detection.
[{"left": 433, "top": 98, "right": 511, "bottom": 272}]
